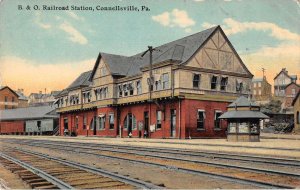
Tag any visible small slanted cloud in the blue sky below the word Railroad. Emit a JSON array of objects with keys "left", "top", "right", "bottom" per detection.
[{"left": 59, "top": 22, "right": 88, "bottom": 45}]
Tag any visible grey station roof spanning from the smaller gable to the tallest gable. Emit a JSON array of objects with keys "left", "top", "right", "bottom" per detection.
[{"left": 89, "top": 26, "right": 252, "bottom": 81}]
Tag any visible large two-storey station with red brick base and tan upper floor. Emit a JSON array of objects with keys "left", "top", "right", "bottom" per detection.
[{"left": 55, "top": 26, "right": 253, "bottom": 139}]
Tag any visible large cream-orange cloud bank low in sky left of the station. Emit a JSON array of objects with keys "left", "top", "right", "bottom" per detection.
[{"left": 0, "top": 56, "right": 95, "bottom": 94}]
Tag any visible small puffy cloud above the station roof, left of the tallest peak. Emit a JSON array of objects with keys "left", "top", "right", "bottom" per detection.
[{"left": 152, "top": 9, "right": 195, "bottom": 28}]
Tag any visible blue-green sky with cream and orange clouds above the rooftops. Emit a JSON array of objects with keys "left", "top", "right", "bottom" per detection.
[{"left": 0, "top": 0, "right": 300, "bottom": 95}]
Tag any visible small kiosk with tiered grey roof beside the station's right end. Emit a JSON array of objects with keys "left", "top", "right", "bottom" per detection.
[{"left": 219, "top": 96, "right": 269, "bottom": 142}]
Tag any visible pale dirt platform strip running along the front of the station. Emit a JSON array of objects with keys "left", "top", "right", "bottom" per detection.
[{"left": 0, "top": 134, "right": 300, "bottom": 158}]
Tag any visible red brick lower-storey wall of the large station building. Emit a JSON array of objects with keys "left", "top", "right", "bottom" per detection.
[{"left": 60, "top": 100, "right": 228, "bottom": 138}]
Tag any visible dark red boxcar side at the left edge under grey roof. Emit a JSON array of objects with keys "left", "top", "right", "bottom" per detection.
[{"left": 0, "top": 121, "right": 25, "bottom": 134}]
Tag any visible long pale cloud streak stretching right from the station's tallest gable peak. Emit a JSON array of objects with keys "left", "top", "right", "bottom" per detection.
[{"left": 202, "top": 18, "right": 300, "bottom": 41}]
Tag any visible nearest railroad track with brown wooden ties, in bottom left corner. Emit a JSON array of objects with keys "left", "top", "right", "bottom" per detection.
[{"left": 0, "top": 148, "right": 162, "bottom": 189}]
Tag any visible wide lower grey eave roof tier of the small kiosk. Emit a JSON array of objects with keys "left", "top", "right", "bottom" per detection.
[{"left": 219, "top": 111, "right": 269, "bottom": 119}]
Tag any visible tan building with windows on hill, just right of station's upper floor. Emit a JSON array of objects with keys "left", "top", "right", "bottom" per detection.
[{"left": 251, "top": 76, "right": 272, "bottom": 102}]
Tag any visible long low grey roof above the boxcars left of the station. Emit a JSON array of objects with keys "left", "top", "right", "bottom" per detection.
[{"left": 0, "top": 106, "right": 58, "bottom": 121}]
